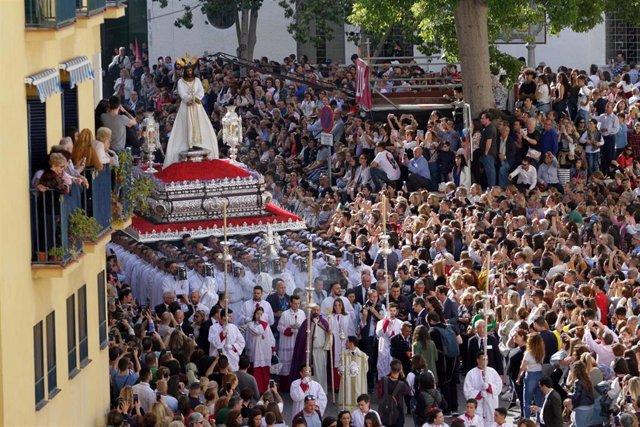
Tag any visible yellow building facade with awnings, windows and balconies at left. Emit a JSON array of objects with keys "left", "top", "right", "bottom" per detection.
[{"left": 0, "top": 0, "right": 125, "bottom": 426}]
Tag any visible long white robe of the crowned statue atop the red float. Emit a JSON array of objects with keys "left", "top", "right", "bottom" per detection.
[{"left": 164, "top": 77, "right": 219, "bottom": 168}]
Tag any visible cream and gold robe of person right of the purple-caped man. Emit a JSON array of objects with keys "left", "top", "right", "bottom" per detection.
[{"left": 338, "top": 347, "right": 369, "bottom": 411}]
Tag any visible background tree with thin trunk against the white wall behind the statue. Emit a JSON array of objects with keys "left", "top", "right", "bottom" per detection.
[{"left": 154, "top": 0, "right": 351, "bottom": 60}]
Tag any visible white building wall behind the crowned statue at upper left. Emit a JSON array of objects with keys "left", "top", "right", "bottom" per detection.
[{"left": 147, "top": 0, "right": 296, "bottom": 64}]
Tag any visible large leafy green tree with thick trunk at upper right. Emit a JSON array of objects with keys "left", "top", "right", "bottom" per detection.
[{"left": 349, "top": 0, "right": 640, "bottom": 116}]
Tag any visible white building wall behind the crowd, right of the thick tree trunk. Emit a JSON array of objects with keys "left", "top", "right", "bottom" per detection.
[{"left": 498, "top": 23, "right": 607, "bottom": 71}]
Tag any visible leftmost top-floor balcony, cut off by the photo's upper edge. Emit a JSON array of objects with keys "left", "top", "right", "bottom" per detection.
[{"left": 24, "top": 0, "right": 76, "bottom": 29}]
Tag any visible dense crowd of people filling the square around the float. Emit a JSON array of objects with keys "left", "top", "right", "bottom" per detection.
[{"left": 99, "top": 42, "right": 640, "bottom": 427}]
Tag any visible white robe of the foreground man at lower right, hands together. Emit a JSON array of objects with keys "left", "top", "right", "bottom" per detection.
[{"left": 464, "top": 366, "right": 502, "bottom": 427}]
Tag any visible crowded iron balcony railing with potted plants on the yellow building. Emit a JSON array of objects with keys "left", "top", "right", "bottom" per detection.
[{"left": 31, "top": 166, "right": 112, "bottom": 266}]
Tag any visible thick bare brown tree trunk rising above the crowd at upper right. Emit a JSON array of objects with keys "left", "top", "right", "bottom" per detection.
[{"left": 454, "top": 0, "right": 495, "bottom": 118}]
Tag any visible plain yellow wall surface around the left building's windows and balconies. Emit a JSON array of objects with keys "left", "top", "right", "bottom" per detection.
[{"left": 0, "top": 0, "right": 116, "bottom": 426}]
